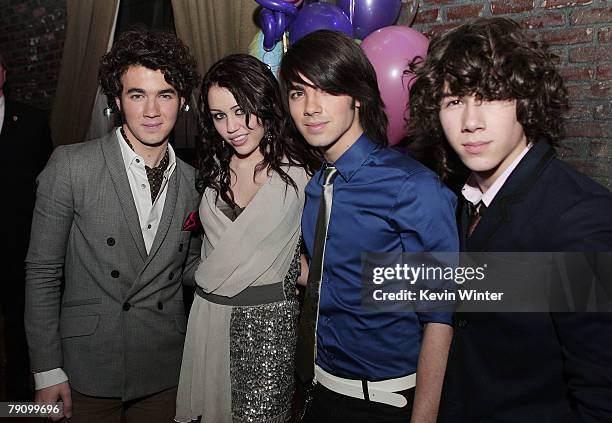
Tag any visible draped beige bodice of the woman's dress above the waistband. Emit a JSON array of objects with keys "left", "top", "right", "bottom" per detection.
[{"left": 195, "top": 167, "right": 307, "bottom": 297}]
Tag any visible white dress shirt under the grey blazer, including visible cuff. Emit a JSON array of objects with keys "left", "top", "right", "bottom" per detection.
[{"left": 34, "top": 128, "right": 176, "bottom": 391}]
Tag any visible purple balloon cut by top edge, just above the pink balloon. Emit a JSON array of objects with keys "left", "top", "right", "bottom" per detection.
[{"left": 336, "top": 0, "right": 402, "bottom": 40}]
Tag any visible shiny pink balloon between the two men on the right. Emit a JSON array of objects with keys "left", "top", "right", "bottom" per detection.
[{"left": 361, "top": 26, "right": 429, "bottom": 145}]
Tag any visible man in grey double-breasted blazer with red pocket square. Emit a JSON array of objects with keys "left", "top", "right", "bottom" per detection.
[{"left": 25, "top": 30, "right": 200, "bottom": 423}]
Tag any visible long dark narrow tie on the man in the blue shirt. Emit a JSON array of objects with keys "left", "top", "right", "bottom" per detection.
[{"left": 295, "top": 167, "right": 337, "bottom": 383}]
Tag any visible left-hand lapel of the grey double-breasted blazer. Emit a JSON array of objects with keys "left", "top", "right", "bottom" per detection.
[{"left": 102, "top": 131, "right": 147, "bottom": 261}]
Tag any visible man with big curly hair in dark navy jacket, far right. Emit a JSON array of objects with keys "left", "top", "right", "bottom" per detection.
[{"left": 409, "top": 18, "right": 612, "bottom": 423}]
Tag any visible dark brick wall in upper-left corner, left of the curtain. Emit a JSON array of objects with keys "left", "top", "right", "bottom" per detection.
[{"left": 0, "top": 0, "right": 66, "bottom": 110}]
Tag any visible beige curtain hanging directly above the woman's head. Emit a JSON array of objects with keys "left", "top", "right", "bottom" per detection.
[{"left": 172, "top": 0, "right": 259, "bottom": 80}]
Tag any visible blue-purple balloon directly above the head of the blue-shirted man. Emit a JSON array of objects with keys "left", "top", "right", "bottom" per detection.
[{"left": 289, "top": 3, "right": 353, "bottom": 44}]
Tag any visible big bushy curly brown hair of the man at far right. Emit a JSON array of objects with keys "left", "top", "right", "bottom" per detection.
[{"left": 405, "top": 18, "right": 568, "bottom": 179}]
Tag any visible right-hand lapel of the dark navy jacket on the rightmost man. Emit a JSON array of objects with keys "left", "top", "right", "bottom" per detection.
[{"left": 462, "top": 139, "right": 555, "bottom": 251}]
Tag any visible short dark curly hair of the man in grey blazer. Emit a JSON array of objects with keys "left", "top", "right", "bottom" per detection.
[{"left": 98, "top": 29, "right": 199, "bottom": 110}]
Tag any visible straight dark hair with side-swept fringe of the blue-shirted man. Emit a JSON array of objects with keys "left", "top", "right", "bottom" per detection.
[{"left": 279, "top": 30, "right": 388, "bottom": 146}]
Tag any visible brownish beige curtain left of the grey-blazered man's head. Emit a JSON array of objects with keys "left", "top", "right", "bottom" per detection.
[{"left": 51, "top": 0, "right": 119, "bottom": 145}]
